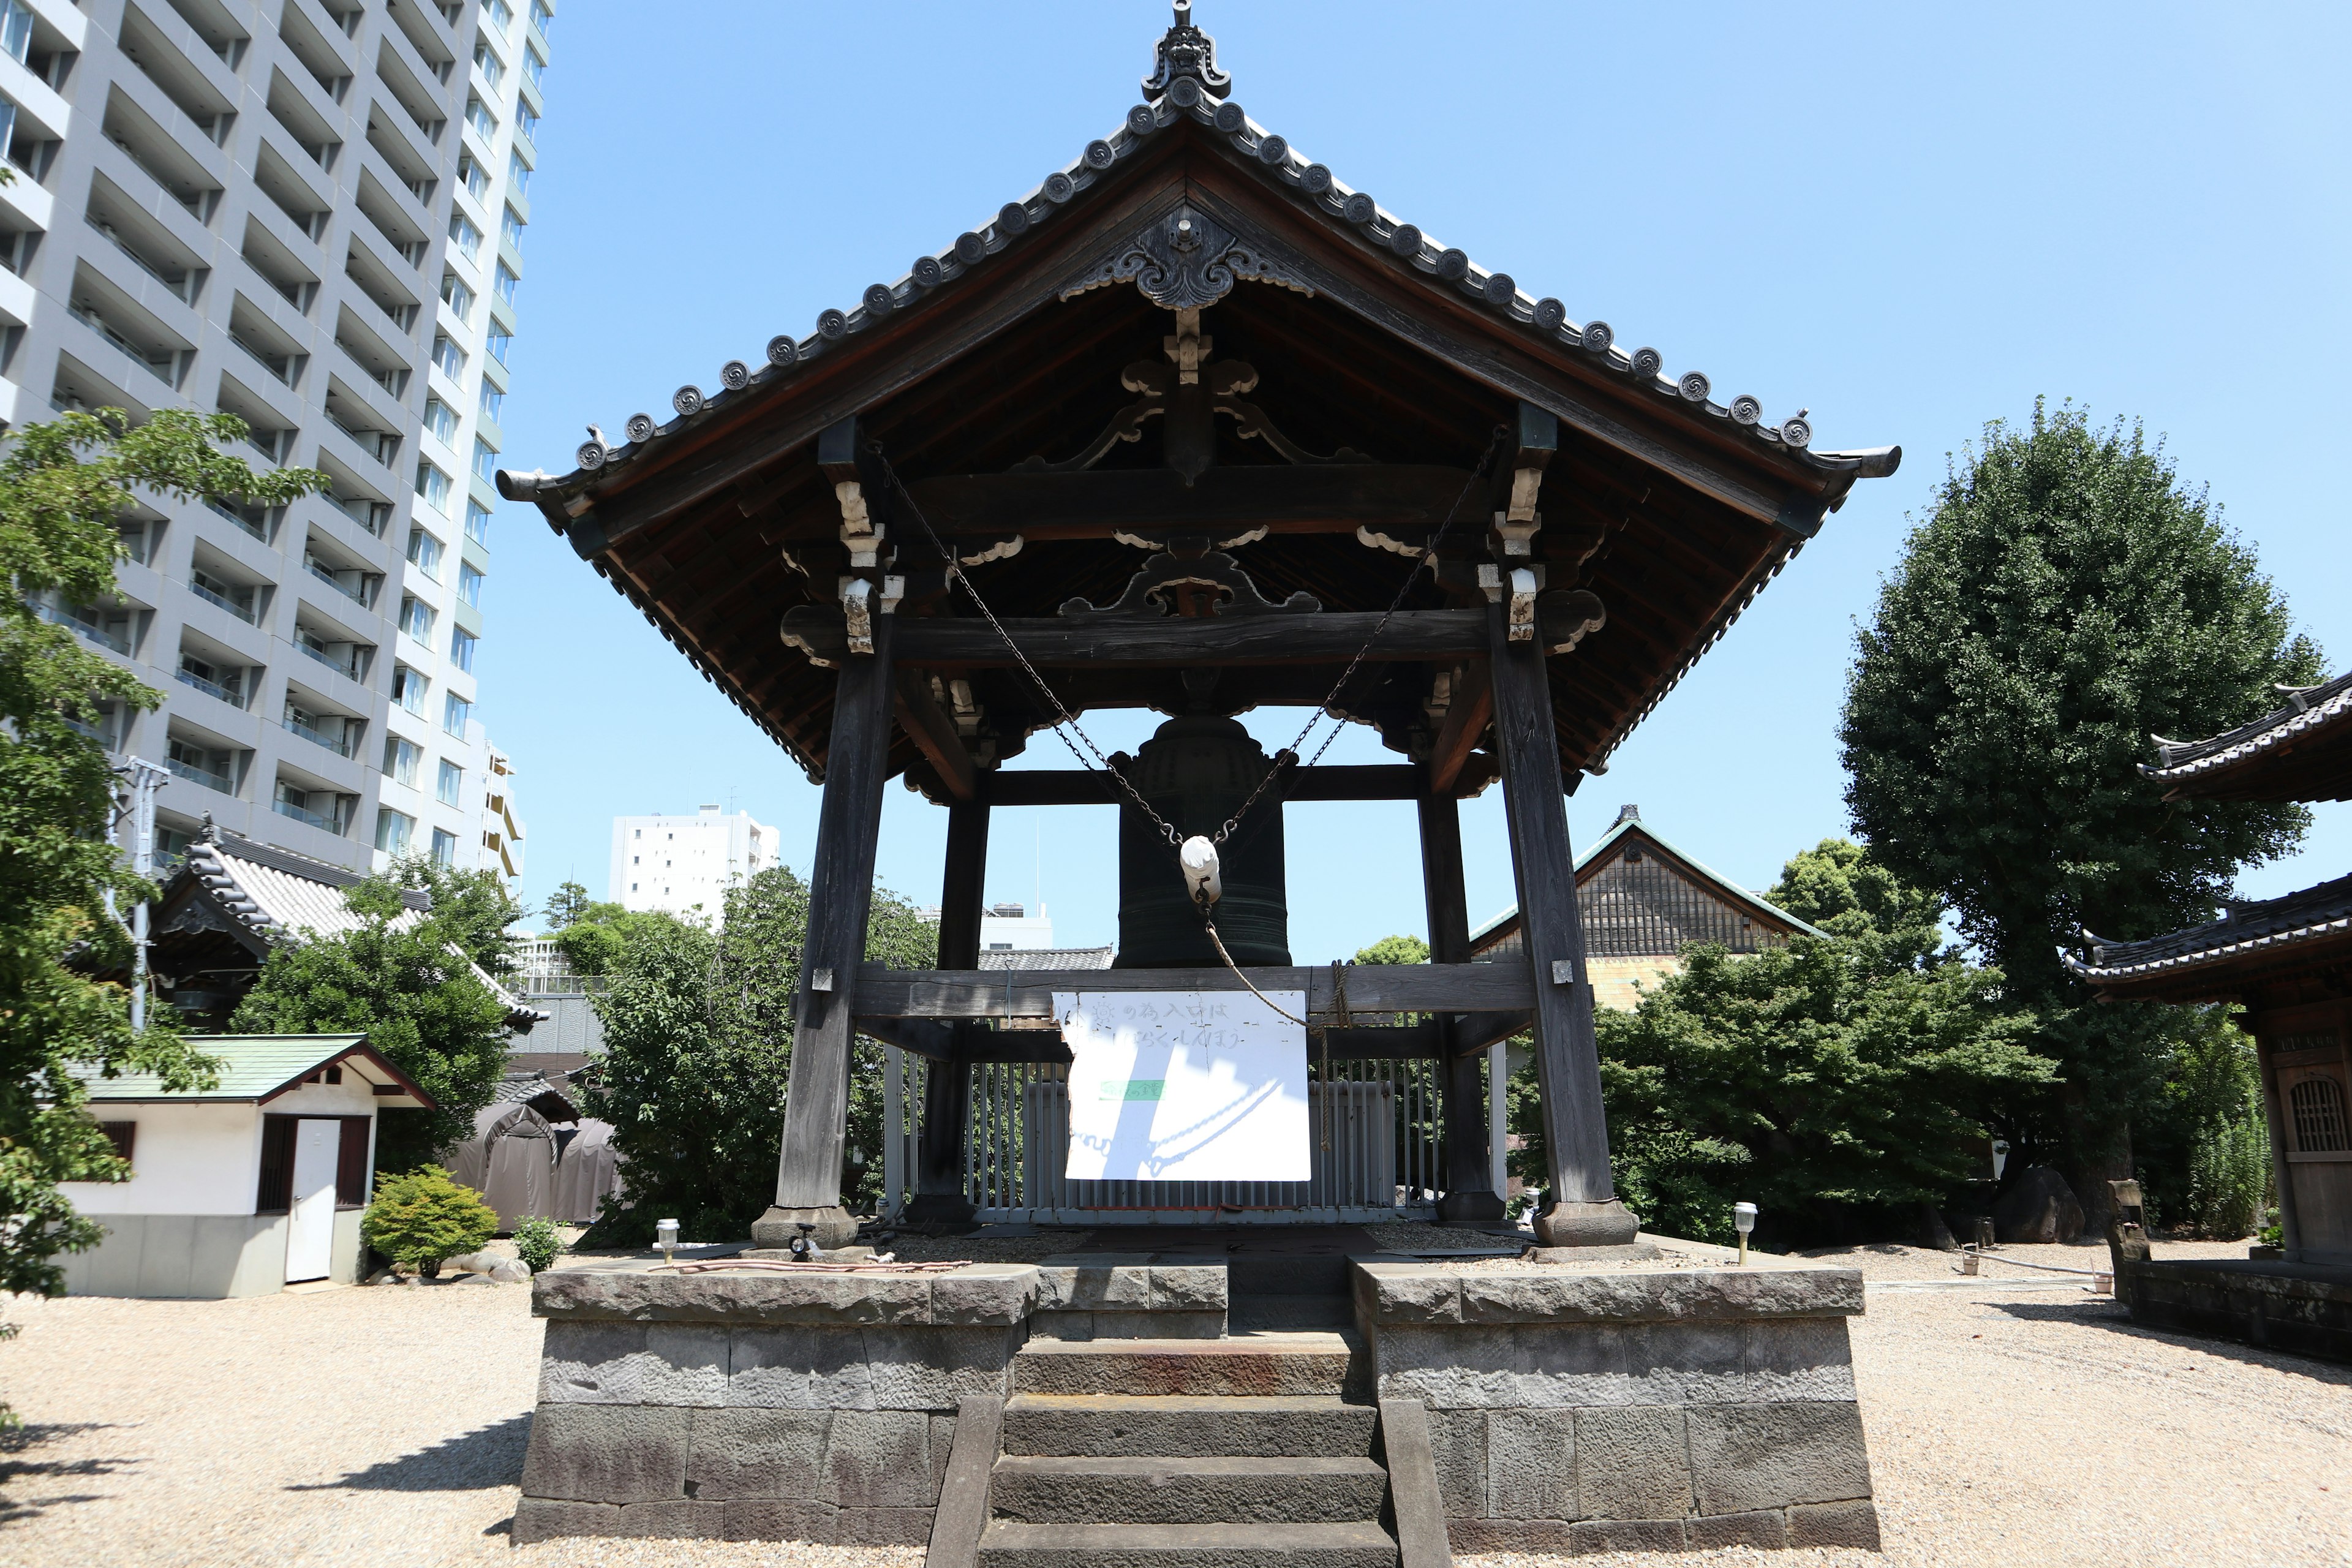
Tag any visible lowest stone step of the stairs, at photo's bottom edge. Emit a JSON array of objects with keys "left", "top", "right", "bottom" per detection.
[{"left": 981, "top": 1518, "right": 1397, "bottom": 1568}]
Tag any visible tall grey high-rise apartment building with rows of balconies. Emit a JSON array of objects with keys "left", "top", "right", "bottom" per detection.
[{"left": 0, "top": 0, "right": 552, "bottom": 875}]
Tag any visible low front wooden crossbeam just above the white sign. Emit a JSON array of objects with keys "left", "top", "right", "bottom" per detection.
[{"left": 856, "top": 964, "right": 1534, "bottom": 1018}]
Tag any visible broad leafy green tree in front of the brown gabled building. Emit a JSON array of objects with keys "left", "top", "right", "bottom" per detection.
[{"left": 1512, "top": 839, "right": 2051, "bottom": 1246}]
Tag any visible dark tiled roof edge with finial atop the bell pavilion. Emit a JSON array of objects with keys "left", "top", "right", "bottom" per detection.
[{"left": 496, "top": 12, "right": 1901, "bottom": 512}]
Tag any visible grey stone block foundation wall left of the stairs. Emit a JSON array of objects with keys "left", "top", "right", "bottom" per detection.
[{"left": 515, "top": 1265, "right": 1037, "bottom": 1547}]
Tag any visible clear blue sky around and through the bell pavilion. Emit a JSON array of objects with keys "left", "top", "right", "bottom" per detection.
[{"left": 480, "top": 0, "right": 2352, "bottom": 962}]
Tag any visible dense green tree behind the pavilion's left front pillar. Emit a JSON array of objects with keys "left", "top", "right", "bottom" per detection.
[{"left": 574, "top": 867, "right": 938, "bottom": 1243}]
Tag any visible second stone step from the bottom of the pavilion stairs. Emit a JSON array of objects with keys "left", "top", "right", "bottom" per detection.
[{"left": 988, "top": 1455, "right": 1388, "bottom": 1523}]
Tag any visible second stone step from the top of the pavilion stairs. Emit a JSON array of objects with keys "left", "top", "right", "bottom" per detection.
[{"left": 1005, "top": 1394, "right": 1381, "bottom": 1460}]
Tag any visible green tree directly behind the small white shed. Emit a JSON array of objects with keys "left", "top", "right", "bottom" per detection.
[{"left": 230, "top": 877, "right": 508, "bottom": 1170}]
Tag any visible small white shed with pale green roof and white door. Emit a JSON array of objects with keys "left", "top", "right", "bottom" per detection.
[{"left": 61, "top": 1035, "right": 433, "bottom": 1298}]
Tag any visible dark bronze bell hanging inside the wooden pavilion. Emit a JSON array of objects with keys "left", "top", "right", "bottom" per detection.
[{"left": 1110, "top": 715, "right": 1291, "bottom": 968}]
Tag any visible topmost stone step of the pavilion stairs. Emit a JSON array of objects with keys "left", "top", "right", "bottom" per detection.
[{"left": 1011, "top": 1333, "right": 1352, "bottom": 1394}]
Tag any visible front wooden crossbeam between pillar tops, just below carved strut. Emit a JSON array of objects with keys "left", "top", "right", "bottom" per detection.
[{"left": 783, "top": 604, "right": 1487, "bottom": 670}]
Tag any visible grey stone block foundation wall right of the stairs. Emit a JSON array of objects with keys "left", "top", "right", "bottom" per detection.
[{"left": 1355, "top": 1260, "right": 1877, "bottom": 1551}]
